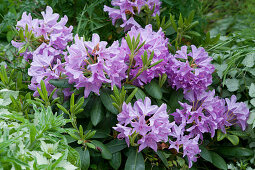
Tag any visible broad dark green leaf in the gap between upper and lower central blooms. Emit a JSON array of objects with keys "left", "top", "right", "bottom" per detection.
[{"left": 145, "top": 80, "right": 162, "bottom": 99}]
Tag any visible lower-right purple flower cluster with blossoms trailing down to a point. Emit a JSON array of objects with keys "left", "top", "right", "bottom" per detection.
[{"left": 170, "top": 91, "right": 249, "bottom": 166}]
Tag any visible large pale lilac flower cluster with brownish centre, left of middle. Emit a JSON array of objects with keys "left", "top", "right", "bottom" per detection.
[{"left": 65, "top": 34, "right": 127, "bottom": 97}]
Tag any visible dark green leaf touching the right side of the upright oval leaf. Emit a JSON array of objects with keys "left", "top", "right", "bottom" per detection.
[{"left": 100, "top": 88, "right": 118, "bottom": 114}]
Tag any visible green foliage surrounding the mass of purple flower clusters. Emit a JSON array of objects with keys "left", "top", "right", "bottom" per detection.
[{"left": 0, "top": 0, "right": 255, "bottom": 169}]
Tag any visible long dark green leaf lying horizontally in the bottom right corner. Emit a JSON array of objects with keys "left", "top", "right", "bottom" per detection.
[{"left": 216, "top": 146, "right": 253, "bottom": 158}]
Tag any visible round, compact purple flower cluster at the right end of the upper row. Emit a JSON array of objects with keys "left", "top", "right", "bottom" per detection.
[{"left": 167, "top": 45, "right": 214, "bottom": 93}]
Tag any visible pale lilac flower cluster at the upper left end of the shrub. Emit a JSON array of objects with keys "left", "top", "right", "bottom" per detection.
[{"left": 12, "top": 6, "right": 73, "bottom": 60}]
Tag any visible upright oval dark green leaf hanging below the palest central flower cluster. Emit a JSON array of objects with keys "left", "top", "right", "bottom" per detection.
[{"left": 90, "top": 98, "right": 103, "bottom": 126}]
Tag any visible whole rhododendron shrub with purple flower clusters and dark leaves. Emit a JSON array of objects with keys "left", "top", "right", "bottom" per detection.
[{"left": 12, "top": 0, "right": 250, "bottom": 168}]
